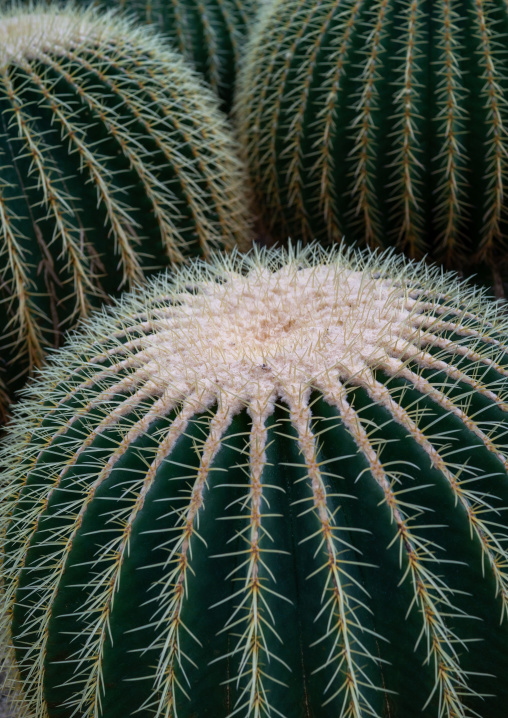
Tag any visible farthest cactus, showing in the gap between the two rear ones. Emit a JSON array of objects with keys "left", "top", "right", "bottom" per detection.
[{"left": 74, "top": 0, "right": 259, "bottom": 111}]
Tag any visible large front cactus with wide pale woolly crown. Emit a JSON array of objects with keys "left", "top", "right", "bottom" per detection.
[{"left": 0, "top": 245, "right": 508, "bottom": 718}]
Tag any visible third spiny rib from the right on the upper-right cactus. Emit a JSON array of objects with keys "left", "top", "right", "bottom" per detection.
[{"left": 387, "top": 0, "right": 425, "bottom": 257}]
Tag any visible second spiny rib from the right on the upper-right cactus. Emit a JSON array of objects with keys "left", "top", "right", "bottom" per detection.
[{"left": 435, "top": 0, "right": 467, "bottom": 262}]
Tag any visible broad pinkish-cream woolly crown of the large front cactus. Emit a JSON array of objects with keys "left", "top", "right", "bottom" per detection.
[{"left": 138, "top": 265, "right": 410, "bottom": 401}]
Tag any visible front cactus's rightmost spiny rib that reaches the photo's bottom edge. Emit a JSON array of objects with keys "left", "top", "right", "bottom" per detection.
[{"left": 324, "top": 386, "right": 480, "bottom": 718}]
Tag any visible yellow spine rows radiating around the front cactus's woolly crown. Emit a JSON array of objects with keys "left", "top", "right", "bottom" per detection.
[{"left": 2, "top": 245, "right": 508, "bottom": 718}]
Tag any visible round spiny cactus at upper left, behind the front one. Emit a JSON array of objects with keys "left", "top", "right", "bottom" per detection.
[{"left": 0, "top": 6, "right": 252, "bottom": 416}]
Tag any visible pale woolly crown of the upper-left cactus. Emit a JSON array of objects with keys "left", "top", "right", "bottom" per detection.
[{"left": 0, "top": 11, "right": 92, "bottom": 67}]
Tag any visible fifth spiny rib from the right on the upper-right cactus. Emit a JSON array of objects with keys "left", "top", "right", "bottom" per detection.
[{"left": 312, "top": 0, "right": 365, "bottom": 238}]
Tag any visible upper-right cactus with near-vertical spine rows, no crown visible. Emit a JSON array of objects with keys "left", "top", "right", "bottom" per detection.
[{"left": 238, "top": 0, "right": 508, "bottom": 269}]
